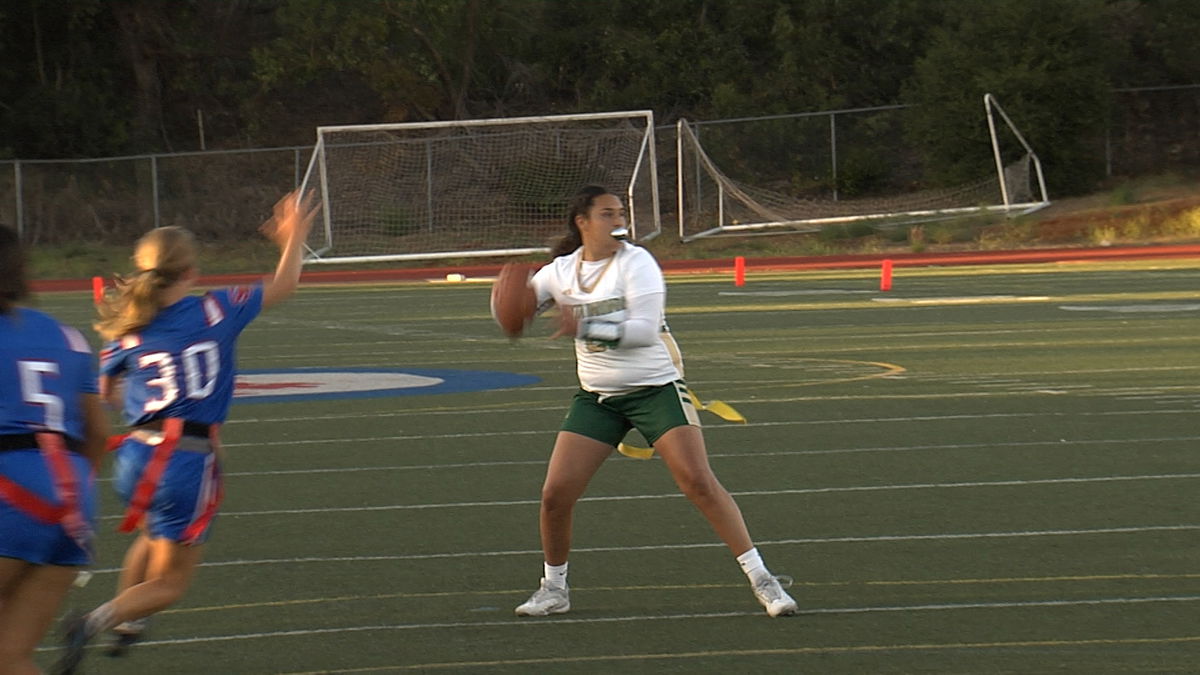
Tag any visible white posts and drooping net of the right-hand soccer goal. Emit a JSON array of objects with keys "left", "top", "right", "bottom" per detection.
[{"left": 676, "top": 94, "right": 1050, "bottom": 241}]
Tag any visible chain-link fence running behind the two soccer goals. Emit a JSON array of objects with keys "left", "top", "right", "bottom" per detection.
[{"left": 0, "top": 84, "right": 1200, "bottom": 245}]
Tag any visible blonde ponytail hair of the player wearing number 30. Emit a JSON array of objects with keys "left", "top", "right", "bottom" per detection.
[{"left": 92, "top": 227, "right": 196, "bottom": 340}]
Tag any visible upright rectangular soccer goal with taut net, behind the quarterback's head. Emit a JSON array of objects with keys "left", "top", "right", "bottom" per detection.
[{"left": 301, "top": 110, "right": 660, "bottom": 263}]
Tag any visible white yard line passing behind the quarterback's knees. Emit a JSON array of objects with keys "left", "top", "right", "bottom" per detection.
[{"left": 101, "top": 473, "right": 1200, "bottom": 520}]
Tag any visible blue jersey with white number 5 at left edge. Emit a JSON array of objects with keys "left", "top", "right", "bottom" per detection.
[{"left": 0, "top": 307, "right": 97, "bottom": 438}]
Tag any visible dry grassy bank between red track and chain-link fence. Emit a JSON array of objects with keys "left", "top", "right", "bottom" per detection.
[{"left": 31, "top": 175, "right": 1200, "bottom": 279}]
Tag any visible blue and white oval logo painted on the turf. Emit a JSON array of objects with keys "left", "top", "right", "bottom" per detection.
[{"left": 233, "top": 368, "right": 540, "bottom": 404}]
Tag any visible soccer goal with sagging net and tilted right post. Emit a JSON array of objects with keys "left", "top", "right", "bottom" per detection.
[{"left": 676, "top": 94, "right": 1050, "bottom": 241}]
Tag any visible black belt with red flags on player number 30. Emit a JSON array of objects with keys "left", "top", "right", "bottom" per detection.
[{"left": 116, "top": 417, "right": 223, "bottom": 544}]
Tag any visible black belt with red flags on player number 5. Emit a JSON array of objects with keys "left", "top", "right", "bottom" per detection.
[{"left": 0, "top": 431, "right": 91, "bottom": 550}]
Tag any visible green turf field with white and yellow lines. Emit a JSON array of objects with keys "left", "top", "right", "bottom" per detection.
[{"left": 30, "top": 255, "right": 1200, "bottom": 674}]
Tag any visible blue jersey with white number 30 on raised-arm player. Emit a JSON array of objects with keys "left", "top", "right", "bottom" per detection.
[{"left": 100, "top": 283, "right": 263, "bottom": 425}]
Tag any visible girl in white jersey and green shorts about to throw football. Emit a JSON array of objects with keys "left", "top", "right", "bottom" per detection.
[{"left": 516, "top": 186, "right": 796, "bottom": 616}]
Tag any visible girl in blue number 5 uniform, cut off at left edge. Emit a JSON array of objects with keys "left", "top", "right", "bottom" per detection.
[{"left": 0, "top": 226, "right": 108, "bottom": 673}]
